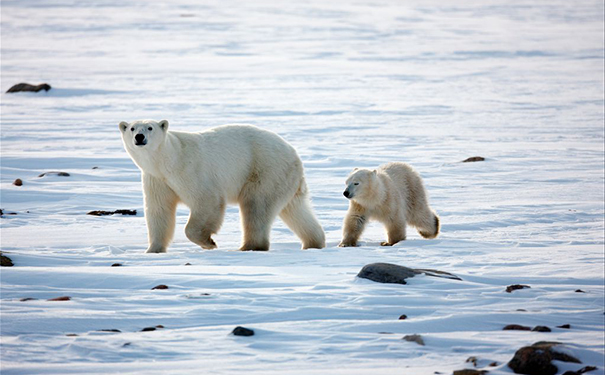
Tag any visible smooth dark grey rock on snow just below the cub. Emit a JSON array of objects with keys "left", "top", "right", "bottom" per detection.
[{"left": 357, "top": 263, "right": 462, "bottom": 284}]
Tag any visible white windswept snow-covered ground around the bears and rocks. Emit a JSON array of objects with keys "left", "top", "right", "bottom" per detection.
[{"left": 0, "top": 0, "right": 605, "bottom": 375}]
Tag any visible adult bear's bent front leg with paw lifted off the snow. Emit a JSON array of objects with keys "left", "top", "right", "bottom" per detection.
[{"left": 185, "top": 198, "right": 226, "bottom": 250}]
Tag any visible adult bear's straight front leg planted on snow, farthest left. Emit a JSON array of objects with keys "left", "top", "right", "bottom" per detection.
[{"left": 142, "top": 173, "right": 179, "bottom": 253}]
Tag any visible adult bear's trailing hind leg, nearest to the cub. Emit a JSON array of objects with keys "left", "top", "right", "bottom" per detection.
[{"left": 279, "top": 179, "right": 326, "bottom": 249}]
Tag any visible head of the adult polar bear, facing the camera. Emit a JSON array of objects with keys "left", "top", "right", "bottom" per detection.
[{"left": 119, "top": 120, "right": 168, "bottom": 151}]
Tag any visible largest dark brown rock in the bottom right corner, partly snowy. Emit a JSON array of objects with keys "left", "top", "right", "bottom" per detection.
[{"left": 508, "top": 341, "right": 581, "bottom": 375}]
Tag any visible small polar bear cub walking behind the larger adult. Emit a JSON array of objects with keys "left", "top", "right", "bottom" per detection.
[{"left": 338, "top": 162, "right": 439, "bottom": 247}]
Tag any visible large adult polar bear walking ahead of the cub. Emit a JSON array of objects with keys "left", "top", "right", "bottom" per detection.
[{"left": 119, "top": 120, "right": 325, "bottom": 253}]
